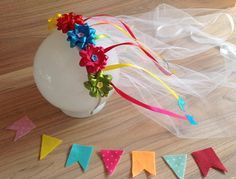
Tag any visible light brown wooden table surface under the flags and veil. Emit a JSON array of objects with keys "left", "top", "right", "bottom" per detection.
[{"left": 0, "top": 0, "right": 236, "bottom": 179}]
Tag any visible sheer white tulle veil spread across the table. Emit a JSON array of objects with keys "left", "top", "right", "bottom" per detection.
[{"left": 85, "top": 4, "right": 236, "bottom": 138}]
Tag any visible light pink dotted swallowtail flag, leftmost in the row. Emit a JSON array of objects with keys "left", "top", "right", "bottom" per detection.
[{"left": 6, "top": 116, "right": 36, "bottom": 141}]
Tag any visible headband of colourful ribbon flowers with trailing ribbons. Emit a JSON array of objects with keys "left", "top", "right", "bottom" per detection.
[{"left": 48, "top": 12, "right": 197, "bottom": 125}]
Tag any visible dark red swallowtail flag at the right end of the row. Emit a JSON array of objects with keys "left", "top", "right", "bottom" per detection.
[{"left": 192, "top": 147, "right": 227, "bottom": 177}]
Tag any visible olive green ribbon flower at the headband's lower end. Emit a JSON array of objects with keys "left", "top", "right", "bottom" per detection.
[{"left": 84, "top": 72, "right": 113, "bottom": 97}]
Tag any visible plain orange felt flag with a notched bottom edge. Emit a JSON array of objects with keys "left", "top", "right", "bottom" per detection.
[{"left": 132, "top": 151, "right": 156, "bottom": 177}]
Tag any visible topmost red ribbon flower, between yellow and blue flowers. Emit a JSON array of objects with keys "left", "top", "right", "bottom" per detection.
[{"left": 57, "top": 12, "right": 84, "bottom": 33}]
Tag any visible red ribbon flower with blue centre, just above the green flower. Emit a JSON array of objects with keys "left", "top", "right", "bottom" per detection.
[{"left": 79, "top": 44, "right": 108, "bottom": 73}]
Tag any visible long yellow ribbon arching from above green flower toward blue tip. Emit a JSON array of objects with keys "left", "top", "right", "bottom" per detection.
[{"left": 103, "top": 63, "right": 179, "bottom": 100}]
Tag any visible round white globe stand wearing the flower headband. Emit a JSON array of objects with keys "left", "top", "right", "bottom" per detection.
[{"left": 34, "top": 30, "right": 119, "bottom": 118}]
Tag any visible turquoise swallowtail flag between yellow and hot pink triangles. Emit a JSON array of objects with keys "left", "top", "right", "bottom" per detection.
[{"left": 66, "top": 144, "right": 94, "bottom": 171}]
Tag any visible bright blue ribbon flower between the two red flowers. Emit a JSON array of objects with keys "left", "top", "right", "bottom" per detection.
[{"left": 67, "top": 23, "right": 96, "bottom": 49}]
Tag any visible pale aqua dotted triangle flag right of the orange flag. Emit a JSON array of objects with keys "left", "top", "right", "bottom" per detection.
[{"left": 163, "top": 154, "right": 187, "bottom": 179}]
